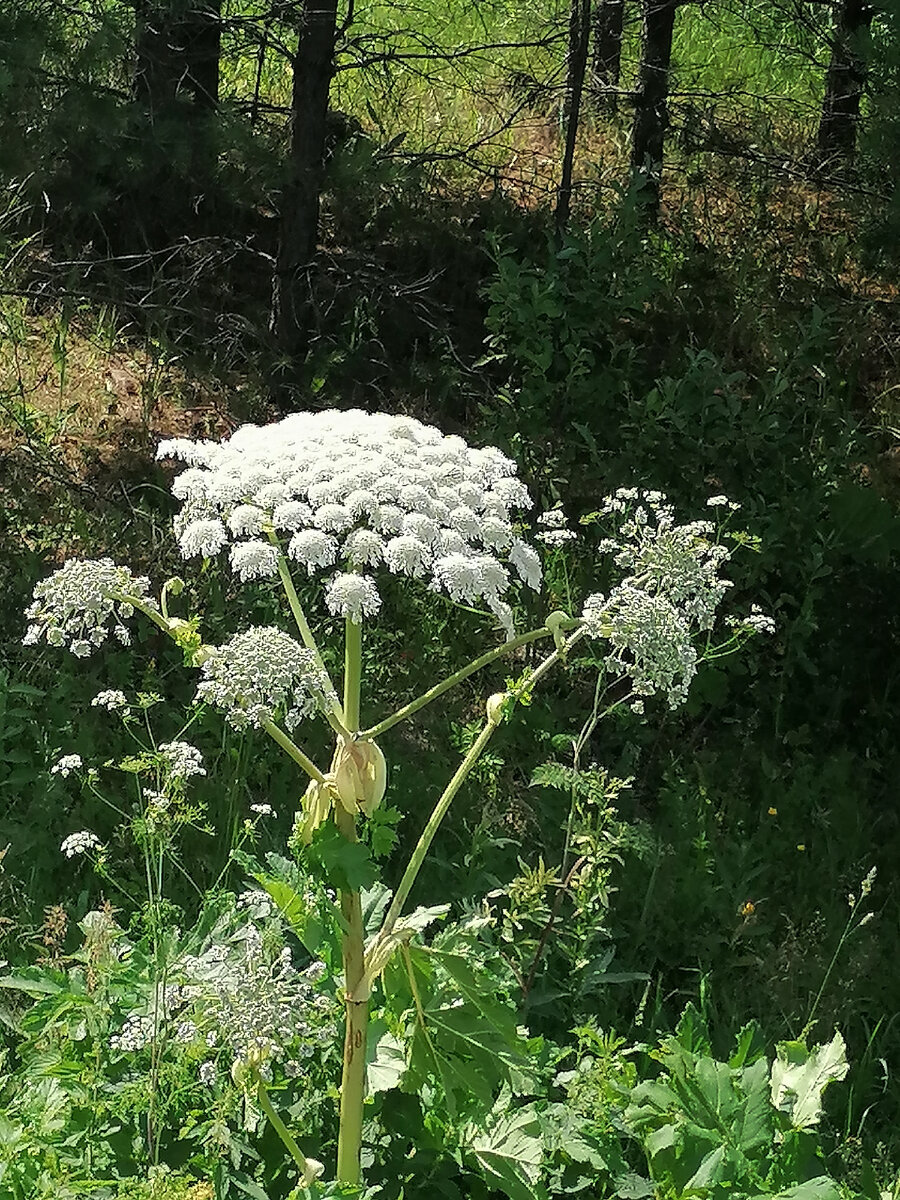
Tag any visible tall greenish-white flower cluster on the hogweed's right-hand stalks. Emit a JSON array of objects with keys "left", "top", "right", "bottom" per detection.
[{"left": 582, "top": 488, "right": 731, "bottom": 712}]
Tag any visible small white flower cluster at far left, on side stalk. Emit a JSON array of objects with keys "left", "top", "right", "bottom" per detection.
[{"left": 23, "top": 558, "right": 156, "bottom": 659}]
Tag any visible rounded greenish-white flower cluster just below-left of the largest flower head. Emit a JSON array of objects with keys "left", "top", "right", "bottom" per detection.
[{"left": 197, "top": 625, "right": 336, "bottom": 730}]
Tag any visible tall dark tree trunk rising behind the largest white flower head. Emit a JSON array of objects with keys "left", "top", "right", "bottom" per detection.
[{"left": 271, "top": 0, "right": 337, "bottom": 410}]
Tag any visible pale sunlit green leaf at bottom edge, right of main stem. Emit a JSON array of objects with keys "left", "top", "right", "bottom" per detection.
[{"left": 463, "top": 1104, "right": 546, "bottom": 1200}]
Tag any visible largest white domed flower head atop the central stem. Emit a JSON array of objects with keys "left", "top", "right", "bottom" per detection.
[{"left": 157, "top": 410, "right": 541, "bottom": 629}]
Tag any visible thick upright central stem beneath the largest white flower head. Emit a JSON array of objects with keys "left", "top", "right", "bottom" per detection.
[{"left": 335, "top": 617, "right": 368, "bottom": 1183}]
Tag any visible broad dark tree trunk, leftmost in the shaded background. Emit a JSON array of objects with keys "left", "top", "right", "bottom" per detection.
[{"left": 134, "top": 0, "right": 222, "bottom": 116}]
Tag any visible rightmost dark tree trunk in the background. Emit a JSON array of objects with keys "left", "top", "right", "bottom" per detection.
[{"left": 816, "top": 0, "right": 872, "bottom": 164}]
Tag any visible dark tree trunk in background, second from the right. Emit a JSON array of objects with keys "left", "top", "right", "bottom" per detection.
[{"left": 631, "top": 0, "right": 678, "bottom": 222}]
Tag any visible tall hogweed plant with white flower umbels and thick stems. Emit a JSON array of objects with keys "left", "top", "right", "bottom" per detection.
[{"left": 24, "top": 412, "right": 770, "bottom": 1184}]
